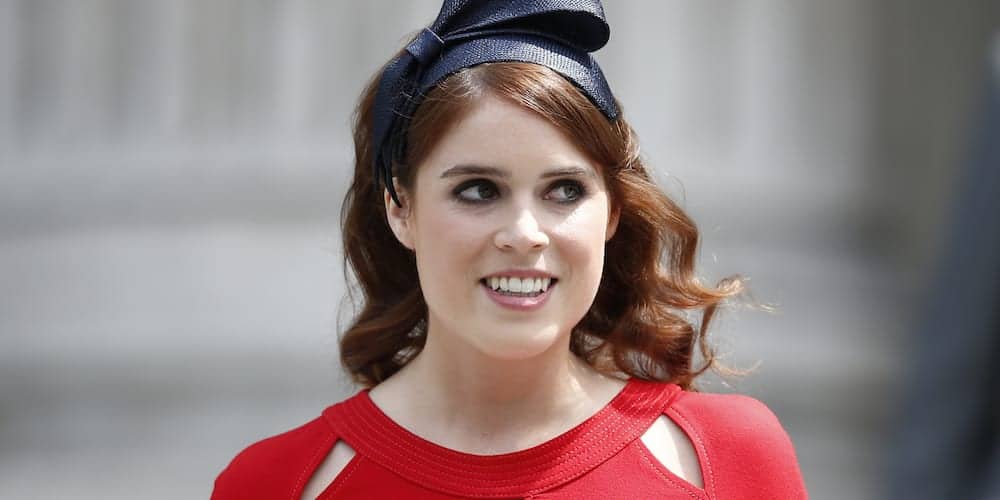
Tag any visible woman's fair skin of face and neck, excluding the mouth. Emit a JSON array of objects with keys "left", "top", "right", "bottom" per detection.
[{"left": 370, "top": 93, "right": 623, "bottom": 454}]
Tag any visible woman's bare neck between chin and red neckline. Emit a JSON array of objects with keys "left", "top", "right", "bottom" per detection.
[{"left": 370, "top": 322, "right": 624, "bottom": 454}]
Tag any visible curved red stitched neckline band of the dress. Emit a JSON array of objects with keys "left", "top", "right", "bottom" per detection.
[{"left": 323, "top": 378, "right": 681, "bottom": 497}]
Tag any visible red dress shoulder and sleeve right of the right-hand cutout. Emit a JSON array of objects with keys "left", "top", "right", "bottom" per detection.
[{"left": 666, "top": 393, "right": 808, "bottom": 500}]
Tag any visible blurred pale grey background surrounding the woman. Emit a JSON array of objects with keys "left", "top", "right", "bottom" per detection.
[{"left": 0, "top": 0, "right": 1000, "bottom": 499}]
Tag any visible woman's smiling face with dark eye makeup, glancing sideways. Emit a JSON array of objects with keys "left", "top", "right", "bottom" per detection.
[{"left": 386, "top": 97, "right": 617, "bottom": 360}]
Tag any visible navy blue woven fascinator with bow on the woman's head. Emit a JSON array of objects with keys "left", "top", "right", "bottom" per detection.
[{"left": 372, "top": 0, "right": 618, "bottom": 206}]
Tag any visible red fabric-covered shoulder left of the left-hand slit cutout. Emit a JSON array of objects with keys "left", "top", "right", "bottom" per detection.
[{"left": 212, "top": 417, "right": 336, "bottom": 500}]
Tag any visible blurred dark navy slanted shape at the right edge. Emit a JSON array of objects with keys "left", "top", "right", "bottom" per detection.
[{"left": 890, "top": 30, "right": 1000, "bottom": 500}]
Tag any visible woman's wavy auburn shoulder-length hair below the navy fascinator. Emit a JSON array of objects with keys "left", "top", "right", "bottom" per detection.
[{"left": 340, "top": 62, "right": 743, "bottom": 389}]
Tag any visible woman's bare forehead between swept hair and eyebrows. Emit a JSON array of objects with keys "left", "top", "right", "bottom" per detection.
[{"left": 420, "top": 96, "right": 597, "bottom": 177}]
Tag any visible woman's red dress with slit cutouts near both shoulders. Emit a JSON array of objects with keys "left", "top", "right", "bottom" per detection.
[{"left": 212, "top": 379, "right": 807, "bottom": 500}]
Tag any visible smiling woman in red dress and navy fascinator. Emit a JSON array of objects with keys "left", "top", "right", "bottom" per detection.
[{"left": 213, "top": 0, "right": 805, "bottom": 499}]
